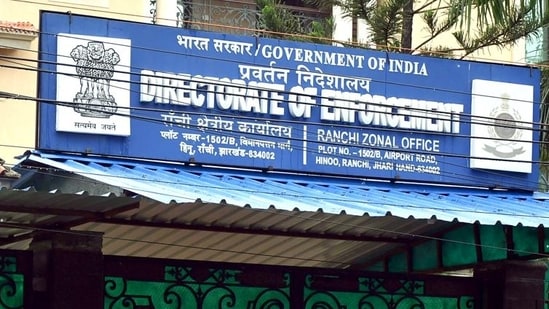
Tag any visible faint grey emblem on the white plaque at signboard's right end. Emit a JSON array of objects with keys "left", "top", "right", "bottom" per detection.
[{"left": 484, "top": 94, "right": 525, "bottom": 159}]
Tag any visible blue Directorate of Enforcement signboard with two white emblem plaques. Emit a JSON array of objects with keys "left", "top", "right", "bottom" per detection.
[{"left": 39, "top": 13, "right": 540, "bottom": 190}]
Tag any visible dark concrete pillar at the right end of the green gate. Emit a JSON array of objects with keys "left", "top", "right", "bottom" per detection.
[{"left": 474, "top": 261, "right": 546, "bottom": 309}]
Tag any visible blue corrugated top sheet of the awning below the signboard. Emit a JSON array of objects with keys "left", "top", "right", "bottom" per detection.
[{"left": 18, "top": 151, "right": 549, "bottom": 227}]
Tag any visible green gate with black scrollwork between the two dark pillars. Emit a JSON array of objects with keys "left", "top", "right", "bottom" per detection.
[{"left": 104, "top": 256, "right": 481, "bottom": 309}]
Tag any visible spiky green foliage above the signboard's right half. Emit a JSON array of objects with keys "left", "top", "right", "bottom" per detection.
[{"left": 332, "top": 0, "right": 549, "bottom": 58}]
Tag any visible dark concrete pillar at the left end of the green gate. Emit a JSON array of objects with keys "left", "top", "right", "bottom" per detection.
[{"left": 29, "top": 231, "right": 105, "bottom": 309}]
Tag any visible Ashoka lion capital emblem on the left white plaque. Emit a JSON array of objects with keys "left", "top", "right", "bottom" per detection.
[{"left": 71, "top": 41, "right": 120, "bottom": 118}]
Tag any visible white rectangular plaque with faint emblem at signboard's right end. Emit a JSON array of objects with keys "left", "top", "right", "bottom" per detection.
[{"left": 469, "top": 79, "right": 535, "bottom": 173}]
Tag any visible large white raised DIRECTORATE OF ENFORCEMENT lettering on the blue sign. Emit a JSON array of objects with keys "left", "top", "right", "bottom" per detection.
[{"left": 140, "top": 69, "right": 464, "bottom": 134}]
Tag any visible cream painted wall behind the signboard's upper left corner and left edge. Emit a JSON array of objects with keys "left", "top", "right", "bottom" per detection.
[{"left": 0, "top": 0, "right": 151, "bottom": 165}]
